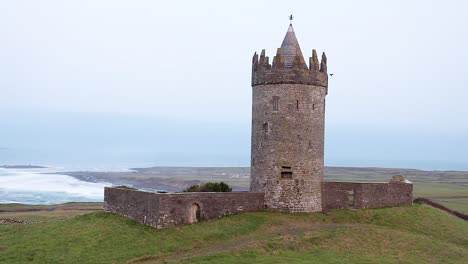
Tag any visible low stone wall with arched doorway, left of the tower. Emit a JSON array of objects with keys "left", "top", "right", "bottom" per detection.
[{"left": 104, "top": 187, "right": 264, "bottom": 228}]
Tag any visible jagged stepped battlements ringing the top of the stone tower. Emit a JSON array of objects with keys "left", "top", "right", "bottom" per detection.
[{"left": 252, "top": 48, "right": 328, "bottom": 87}]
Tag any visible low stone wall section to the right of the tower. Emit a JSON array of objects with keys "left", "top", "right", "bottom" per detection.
[{"left": 322, "top": 182, "right": 413, "bottom": 211}]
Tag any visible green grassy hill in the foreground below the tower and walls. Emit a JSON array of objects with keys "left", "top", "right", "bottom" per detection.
[{"left": 0, "top": 205, "right": 468, "bottom": 263}]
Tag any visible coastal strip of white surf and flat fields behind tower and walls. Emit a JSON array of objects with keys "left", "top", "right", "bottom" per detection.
[{"left": 0, "top": 167, "right": 468, "bottom": 213}]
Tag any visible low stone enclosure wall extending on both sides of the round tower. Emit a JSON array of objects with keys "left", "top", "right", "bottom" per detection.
[{"left": 104, "top": 182, "right": 413, "bottom": 228}]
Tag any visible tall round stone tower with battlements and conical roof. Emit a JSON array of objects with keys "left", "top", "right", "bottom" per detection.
[{"left": 250, "top": 24, "right": 328, "bottom": 212}]
